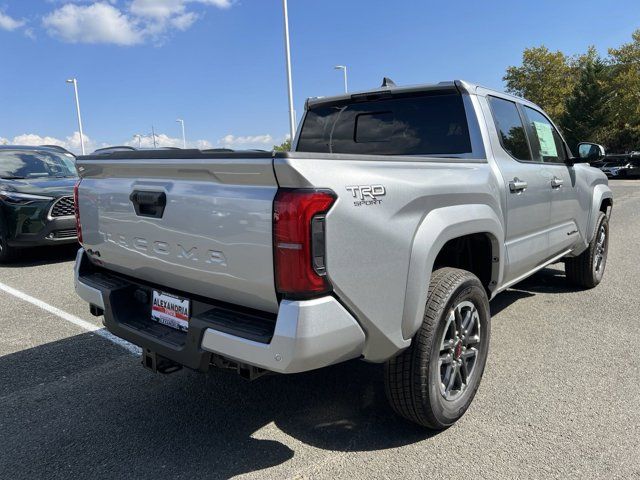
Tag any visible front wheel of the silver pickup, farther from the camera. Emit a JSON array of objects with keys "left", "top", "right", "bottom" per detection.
[{"left": 564, "top": 212, "right": 609, "bottom": 288}]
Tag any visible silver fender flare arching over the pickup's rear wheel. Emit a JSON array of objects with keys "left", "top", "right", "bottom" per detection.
[{"left": 402, "top": 204, "right": 505, "bottom": 339}]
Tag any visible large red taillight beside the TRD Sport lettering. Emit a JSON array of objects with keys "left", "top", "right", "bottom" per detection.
[{"left": 273, "top": 189, "right": 336, "bottom": 298}]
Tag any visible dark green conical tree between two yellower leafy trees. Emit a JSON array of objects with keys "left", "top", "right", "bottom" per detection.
[{"left": 558, "top": 47, "right": 612, "bottom": 151}]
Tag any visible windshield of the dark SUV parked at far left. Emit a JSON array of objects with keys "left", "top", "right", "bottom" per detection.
[{"left": 0, "top": 150, "right": 76, "bottom": 178}]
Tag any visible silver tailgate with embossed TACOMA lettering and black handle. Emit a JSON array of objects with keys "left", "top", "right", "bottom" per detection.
[{"left": 78, "top": 151, "right": 278, "bottom": 312}]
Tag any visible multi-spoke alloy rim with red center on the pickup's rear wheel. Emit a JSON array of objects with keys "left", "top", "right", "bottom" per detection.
[{"left": 438, "top": 300, "right": 481, "bottom": 401}]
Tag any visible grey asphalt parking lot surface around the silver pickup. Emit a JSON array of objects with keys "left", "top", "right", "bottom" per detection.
[{"left": 0, "top": 180, "right": 640, "bottom": 479}]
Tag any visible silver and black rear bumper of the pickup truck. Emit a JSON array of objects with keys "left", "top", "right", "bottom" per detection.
[{"left": 75, "top": 249, "right": 365, "bottom": 373}]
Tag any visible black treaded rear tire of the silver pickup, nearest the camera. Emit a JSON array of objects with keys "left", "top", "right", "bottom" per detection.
[{"left": 384, "top": 267, "right": 491, "bottom": 430}]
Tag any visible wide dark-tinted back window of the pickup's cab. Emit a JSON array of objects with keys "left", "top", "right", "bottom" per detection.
[{"left": 297, "top": 94, "right": 471, "bottom": 156}]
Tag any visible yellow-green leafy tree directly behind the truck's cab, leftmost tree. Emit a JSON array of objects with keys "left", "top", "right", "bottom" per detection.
[{"left": 503, "top": 46, "right": 575, "bottom": 120}]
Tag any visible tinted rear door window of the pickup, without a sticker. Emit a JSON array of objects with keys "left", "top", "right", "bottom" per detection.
[{"left": 489, "top": 97, "right": 531, "bottom": 161}]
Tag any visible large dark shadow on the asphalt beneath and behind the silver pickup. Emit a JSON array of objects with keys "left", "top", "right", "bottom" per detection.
[{"left": 0, "top": 334, "right": 434, "bottom": 478}]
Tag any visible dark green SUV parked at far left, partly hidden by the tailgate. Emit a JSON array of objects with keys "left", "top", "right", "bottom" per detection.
[{"left": 0, "top": 145, "right": 77, "bottom": 262}]
